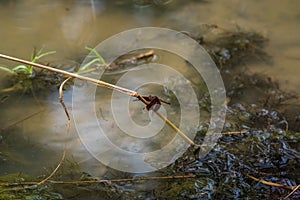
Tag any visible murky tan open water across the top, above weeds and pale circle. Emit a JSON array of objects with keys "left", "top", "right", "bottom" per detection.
[{"left": 0, "top": 0, "right": 300, "bottom": 93}]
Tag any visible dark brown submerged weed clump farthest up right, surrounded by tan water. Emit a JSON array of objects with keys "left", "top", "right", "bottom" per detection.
[{"left": 187, "top": 24, "right": 272, "bottom": 70}]
